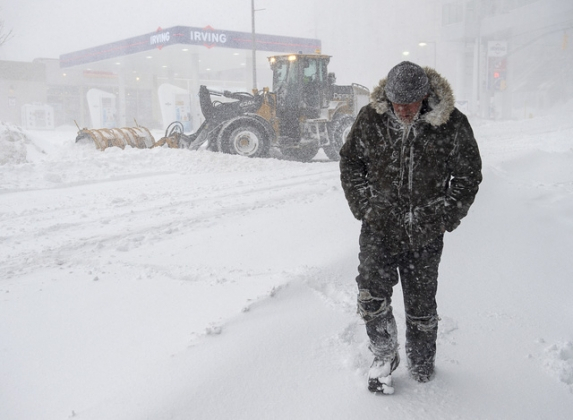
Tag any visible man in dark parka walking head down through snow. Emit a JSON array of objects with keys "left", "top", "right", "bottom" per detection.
[{"left": 340, "top": 61, "right": 482, "bottom": 394}]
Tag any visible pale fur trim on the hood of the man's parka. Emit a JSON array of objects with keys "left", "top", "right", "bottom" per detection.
[{"left": 370, "top": 67, "right": 455, "bottom": 127}]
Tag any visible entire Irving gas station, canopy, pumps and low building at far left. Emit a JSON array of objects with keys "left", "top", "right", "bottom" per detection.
[{"left": 0, "top": 26, "right": 321, "bottom": 132}]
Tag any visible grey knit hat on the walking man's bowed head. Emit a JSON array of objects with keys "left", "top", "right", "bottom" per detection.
[{"left": 384, "top": 61, "right": 430, "bottom": 104}]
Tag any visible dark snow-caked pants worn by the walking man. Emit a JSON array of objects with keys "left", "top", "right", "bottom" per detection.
[{"left": 356, "top": 224, "right": 444, "bottom": 368}]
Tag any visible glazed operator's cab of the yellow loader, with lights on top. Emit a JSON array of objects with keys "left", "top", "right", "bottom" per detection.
[{"left": 269, "top": 54, "right": 331, "bottom": 138}]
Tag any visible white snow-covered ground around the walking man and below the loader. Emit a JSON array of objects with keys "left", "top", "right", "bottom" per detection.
[{"left": 0, "top": 103, "right": 573, "bottom": 420}]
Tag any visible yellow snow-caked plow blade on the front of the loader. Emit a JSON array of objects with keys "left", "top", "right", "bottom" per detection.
[{"left": 76, "top": 127, "right": 155, "bottom": 150}]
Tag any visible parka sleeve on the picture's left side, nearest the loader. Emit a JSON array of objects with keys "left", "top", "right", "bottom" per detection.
[{"left": 340, "top": 107, "right": 371, "bottom": 220}]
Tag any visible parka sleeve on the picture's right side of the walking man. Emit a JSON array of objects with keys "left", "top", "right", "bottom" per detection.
[{"left": 444, "top": 111, "right": 482, "bottom": 232}]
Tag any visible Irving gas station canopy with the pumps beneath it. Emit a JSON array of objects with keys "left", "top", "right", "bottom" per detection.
[{"left": 54, "top": 26, "right": 321, "bottom": 129}]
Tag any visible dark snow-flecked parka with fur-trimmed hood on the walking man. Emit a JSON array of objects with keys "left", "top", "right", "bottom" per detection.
[{"left": 340, "top": 67, "right": 482, "bottom": 253}]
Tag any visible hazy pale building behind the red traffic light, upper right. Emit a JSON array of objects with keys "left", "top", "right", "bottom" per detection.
[{"left": 438, "top": 0, "right": 573, "bottom": 119}]
